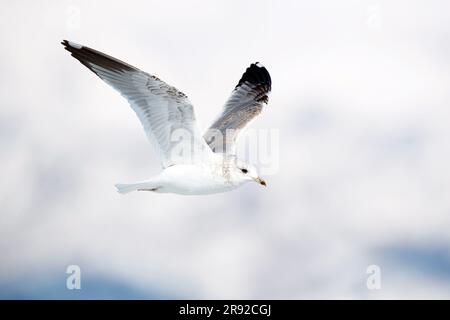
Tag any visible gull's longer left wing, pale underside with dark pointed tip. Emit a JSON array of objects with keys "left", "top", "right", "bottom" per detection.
[{"left": 62, "top": 40, "right": 211, "bottom": 168}]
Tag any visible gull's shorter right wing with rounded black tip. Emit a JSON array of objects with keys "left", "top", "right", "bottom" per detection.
[{"left": 204, "top": 62, "right": 272, "bottom": 153}]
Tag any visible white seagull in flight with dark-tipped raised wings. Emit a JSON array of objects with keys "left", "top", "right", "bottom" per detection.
[{"left": 61, "top": 40, "right": 272, "bottom": 195}]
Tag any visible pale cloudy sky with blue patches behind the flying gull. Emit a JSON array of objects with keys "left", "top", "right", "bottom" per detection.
[{"left": 0, "top": 0, "right": 450, "bottom": 299}]
